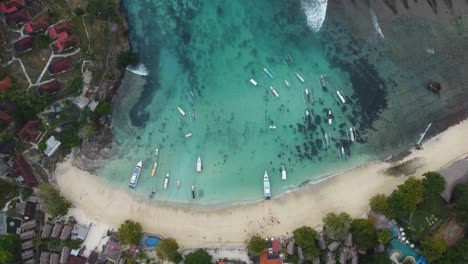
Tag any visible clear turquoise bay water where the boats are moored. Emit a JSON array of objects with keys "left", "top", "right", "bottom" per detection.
[{"left": 97, "top": 0, "right": 454, "bottom": 204}]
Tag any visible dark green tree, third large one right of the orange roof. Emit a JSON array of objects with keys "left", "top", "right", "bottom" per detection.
[{"left": 351, "top": 218, "right": 376, "bottom": 249}]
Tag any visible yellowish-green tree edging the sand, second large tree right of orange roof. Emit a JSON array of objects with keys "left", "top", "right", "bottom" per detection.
[{"left": 323, "top": 212, "right": 351, "bottom": 240}]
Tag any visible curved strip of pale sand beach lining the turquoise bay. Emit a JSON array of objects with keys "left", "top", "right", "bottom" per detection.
[{"left": 56, "top": 121, "right": 468, "bottom": 247}]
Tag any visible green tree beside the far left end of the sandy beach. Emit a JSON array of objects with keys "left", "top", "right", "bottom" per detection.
[{"left": 37, "top": 182, "right": 71, "bottom": 217}]
